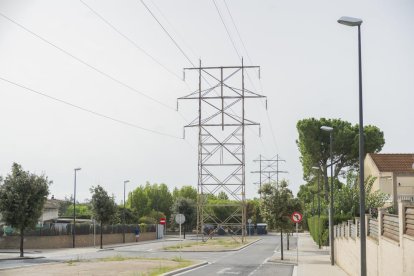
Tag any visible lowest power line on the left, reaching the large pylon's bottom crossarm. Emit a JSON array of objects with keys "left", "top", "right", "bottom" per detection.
[{"left": 0, "top": 76, "right": 182, "bottom": 139}]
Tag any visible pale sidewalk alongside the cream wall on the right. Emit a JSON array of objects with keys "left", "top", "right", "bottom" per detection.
[{"left": 269, "top": 232, "right": 347, "bottom": 276}]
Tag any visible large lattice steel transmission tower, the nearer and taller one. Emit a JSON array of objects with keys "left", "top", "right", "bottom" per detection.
[{"left": 178, "top": 60, "right": 265, "bottom": 242}]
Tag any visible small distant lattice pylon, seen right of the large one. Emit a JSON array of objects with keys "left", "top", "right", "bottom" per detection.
[{"left": 251, "top": 154, "right": 287, "bottom": 198}]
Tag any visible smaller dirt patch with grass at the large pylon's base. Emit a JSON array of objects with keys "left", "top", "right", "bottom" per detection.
[{"left": 164, "top": 237, "right": 258, "bottom": 252}]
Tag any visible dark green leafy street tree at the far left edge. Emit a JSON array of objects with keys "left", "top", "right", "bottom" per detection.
[{"left": 0, "top": 163, "right": 51, "bottom": 257}]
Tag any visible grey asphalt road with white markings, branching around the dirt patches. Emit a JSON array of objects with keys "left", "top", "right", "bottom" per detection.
[{"left": 0, "top": 235, "right": 296, "bottom": 276}]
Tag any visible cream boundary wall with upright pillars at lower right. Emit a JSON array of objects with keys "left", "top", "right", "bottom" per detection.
[{"left": 335, "top": 202, "right": 414, "bottom": 276}]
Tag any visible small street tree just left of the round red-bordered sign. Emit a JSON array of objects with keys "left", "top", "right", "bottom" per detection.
[{"left": 260, "top": 180, "right": 302, "bottom": 260}]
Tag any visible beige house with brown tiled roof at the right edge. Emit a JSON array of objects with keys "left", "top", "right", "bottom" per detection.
[{"left": 364, "top": 153, "right": 414, "bottom": 207}]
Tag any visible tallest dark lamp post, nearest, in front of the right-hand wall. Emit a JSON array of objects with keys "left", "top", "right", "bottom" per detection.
[{"left": 338, "top": 16, "right": 367, "bottom": 276}]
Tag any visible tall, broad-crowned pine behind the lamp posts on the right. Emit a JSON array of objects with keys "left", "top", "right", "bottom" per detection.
[{"left": 296, "top": 118, "right": 385, "bottom": 201}]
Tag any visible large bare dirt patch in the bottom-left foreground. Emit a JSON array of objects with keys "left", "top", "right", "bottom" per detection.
[{"left": 1, "top": 259, "right": 193, "bottom": 276}]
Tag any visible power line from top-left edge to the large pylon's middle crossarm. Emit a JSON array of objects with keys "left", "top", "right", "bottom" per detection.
[{"left": 0, "top": 12, "right": 175, "bottom": 111}]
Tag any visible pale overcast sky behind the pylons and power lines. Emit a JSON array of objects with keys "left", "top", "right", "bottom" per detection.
[{"left": 0, "top": 0, "right": 414, "bottom": 202}]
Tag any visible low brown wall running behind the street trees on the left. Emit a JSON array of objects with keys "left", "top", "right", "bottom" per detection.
[{"left": 0, "top": 232, "right": 156, "bottom": 249}]
